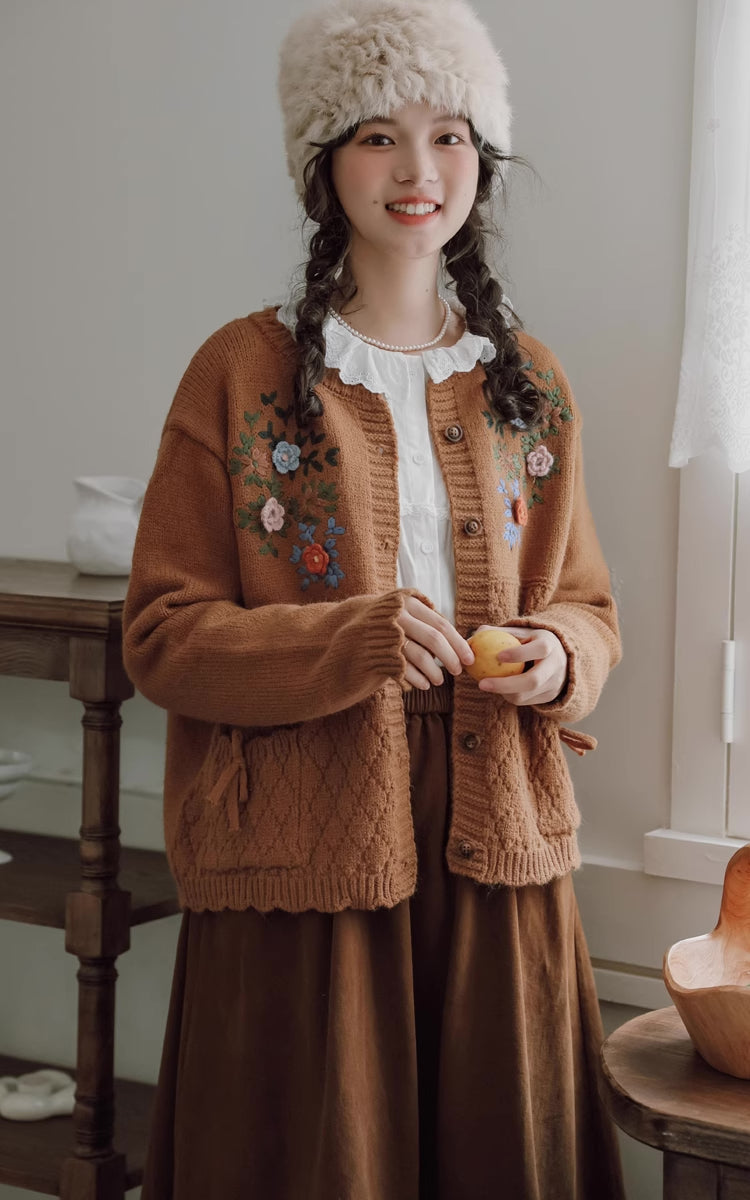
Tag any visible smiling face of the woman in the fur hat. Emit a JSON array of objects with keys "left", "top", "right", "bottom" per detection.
[{"left": 332, "top": 104, "right": 479, "bottom": 258}]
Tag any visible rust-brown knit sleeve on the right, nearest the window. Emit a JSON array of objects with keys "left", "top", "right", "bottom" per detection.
[{"left": 512, "top": 364, "right": 622, "bottom": 722}]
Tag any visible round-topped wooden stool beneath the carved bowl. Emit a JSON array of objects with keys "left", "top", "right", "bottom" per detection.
[{"left": 599, "top": 1007, "right": 750, "bottom": 1200}]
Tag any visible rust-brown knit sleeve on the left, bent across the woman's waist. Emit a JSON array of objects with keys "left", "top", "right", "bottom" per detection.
[{"left": 124, "top": 422, "right": 415, "bottom": 726}]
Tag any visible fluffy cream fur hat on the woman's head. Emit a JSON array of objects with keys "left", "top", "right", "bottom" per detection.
[{"left": 278, "top": 0, "right": 511, "bottom": 196}]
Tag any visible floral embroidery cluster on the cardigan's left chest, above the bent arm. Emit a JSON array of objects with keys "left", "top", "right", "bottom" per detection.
[{"left": 229, "top": 392, "right": 346, "bottom": 590}]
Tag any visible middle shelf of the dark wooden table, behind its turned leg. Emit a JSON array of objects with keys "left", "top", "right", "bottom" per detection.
[{"left": 0, "top": 829, "right": 180, "bottom": 926}]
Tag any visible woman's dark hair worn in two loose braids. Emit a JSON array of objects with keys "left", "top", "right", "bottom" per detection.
[{"left": 294, "top": 121, "right": 542, "bottom": 427}]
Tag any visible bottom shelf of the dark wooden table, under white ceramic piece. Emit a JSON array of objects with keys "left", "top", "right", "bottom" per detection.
[{"left": 0, "top": 1055, "right": 155, "bottom": 1196}]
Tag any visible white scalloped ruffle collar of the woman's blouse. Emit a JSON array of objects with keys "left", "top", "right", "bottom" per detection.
[{"left": 276, "top": 304, "right": 496, "bottom": 392}]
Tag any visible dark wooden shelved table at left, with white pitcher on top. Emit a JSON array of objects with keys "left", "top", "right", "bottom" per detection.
[{"left": 0, "top": 559, "right": 179, "bottom": 1200}]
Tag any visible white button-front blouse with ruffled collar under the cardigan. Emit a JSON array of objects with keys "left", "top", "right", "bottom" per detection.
[{"left": 278, "top": 305, "right": 496, "bottom": 622}]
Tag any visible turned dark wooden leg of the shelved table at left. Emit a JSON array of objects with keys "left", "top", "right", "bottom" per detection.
[{"left": 60, "top": 640, "right": 132, "bottom": 1200}]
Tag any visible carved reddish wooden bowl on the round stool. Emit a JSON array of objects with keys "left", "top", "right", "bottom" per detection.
[{"left": 664, "top": 845, "right": 750, "bottom": 1079}]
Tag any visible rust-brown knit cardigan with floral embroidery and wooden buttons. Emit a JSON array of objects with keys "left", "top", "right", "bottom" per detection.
[{"left": 125, "top": 308, "right": 619, "bottom": 912}]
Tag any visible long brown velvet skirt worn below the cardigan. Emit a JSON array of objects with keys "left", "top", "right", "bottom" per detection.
[{"left": 142, "top": 684, "right": 624, "bottom": 1200}]
